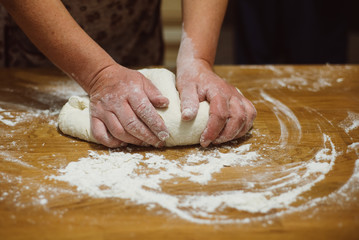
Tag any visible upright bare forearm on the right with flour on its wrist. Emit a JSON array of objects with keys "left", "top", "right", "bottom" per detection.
[{"left": 179, "top": 0, "right": 228, "bottom": 65}]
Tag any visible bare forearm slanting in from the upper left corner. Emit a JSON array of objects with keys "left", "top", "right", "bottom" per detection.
[{"left": 1, "top": 0, "right": 115, "bottom": 92}]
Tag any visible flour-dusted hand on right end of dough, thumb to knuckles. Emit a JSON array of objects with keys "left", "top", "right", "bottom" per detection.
[{"left": 177, "top": 60, "right": 257, "bottom": 147}]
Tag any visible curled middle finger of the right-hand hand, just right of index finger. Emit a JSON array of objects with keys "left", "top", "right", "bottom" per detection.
[{"left": 213, "top": 97, "right": 247, "bottom": 144}]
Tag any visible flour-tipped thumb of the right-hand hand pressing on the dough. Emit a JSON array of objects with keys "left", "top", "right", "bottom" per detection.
[{"left": 179, "top": 84, "right": 199, "bottom": 121}]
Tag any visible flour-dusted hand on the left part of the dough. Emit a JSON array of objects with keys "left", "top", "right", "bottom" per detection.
[{"left": 89, "top": 64, "right": 169, "bottom": 147}]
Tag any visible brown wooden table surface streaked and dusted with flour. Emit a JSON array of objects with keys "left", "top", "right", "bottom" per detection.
[{"left": 0, "top": 65, "right": 359, "bottom": 239}]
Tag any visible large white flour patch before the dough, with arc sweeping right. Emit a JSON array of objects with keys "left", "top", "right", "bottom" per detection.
[{"left": 50, "top": 131, "right": 338, "bottom": 223}]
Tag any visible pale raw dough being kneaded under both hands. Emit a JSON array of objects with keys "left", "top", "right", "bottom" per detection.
[{"left": 59, "top": 69, "right": 209, "bottom": 146}]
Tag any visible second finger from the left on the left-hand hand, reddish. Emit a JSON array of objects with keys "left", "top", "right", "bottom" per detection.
[{"left": 103, "top": 112, "right": 143, "bottom": 145}]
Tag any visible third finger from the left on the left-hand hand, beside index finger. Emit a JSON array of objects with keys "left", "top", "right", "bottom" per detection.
[{"left": 116, "top": 103, "right": 164, "bottom": 147}]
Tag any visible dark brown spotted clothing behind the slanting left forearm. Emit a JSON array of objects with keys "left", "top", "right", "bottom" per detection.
[{"left": 0, "top": 0, "right": 164, "bottom": 67}]
